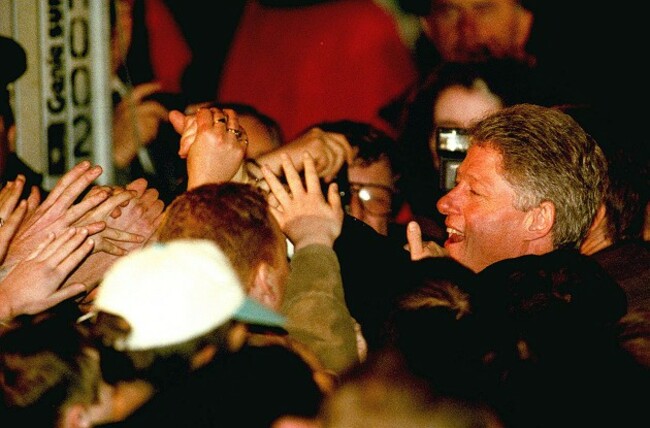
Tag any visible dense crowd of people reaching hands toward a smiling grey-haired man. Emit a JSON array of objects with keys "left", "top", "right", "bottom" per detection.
[{"left": 0, "top": 0, "right": 650, "bottom": 428}]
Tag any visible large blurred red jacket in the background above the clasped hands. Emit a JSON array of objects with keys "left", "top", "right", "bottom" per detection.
[{"left": 217, "top": 0, "right": 417, "bottom": 140}]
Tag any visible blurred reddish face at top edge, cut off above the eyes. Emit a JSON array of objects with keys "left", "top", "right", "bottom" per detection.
[{"left": 421, "top": 0, "right": 533, "bottom": 62}]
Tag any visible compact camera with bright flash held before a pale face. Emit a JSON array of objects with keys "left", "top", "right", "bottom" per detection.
[{"left": 436, "top": 127, "right": 469, "bottom": 192}]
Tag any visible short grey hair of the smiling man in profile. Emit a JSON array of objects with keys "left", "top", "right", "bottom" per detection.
[{"left": 470, "top": 104, "right": 607, "bottom": 249}]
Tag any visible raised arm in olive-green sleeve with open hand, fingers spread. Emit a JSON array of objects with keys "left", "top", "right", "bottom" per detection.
[{"left": 262, "top": 152, "right": 359, "bottom": 374}]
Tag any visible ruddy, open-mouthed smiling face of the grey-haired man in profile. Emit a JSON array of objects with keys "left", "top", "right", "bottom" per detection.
[{"left": 437, "top": 145, "right": 529, "bottom": 272}]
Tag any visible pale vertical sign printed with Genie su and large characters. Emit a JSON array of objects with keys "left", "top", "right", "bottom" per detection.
[{"left": 4, "top": 0, "right": 113, "bottom": 189}]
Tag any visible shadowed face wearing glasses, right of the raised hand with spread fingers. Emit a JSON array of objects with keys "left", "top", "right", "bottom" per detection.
[{"left": 348, "top": 158, "right": 394, "bottom": 235}]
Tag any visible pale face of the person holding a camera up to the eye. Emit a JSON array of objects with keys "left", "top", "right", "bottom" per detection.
[{"left": 429, "top": 82, "right": 503, "bottom": 169}]
